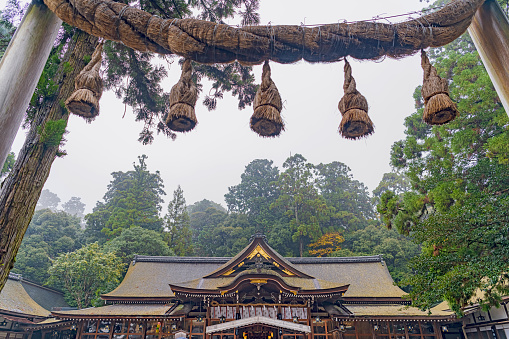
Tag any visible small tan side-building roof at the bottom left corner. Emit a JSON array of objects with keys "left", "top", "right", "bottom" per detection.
[{"left": 0, "top": 273, "right": 50, "bottom": 317}]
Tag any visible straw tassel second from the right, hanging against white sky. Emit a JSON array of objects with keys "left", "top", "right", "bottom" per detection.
[{"left": 338, "top": 59, "right": 374, "bottom": 139}]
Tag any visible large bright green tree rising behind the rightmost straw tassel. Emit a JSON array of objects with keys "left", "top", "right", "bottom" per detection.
[{"left": 377, "top": 11, "right": 509, "bottom": 313}]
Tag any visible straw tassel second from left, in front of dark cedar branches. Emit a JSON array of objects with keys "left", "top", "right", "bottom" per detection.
[{"left": 166, "top": 59, "right": 198, "bottom": 132}]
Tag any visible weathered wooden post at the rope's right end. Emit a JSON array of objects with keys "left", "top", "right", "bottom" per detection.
[{"left": 468, "top": 0, "right": 509, "bottom": 115}]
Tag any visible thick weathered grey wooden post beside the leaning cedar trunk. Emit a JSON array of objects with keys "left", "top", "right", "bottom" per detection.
[{"left": 0, "top": 2, "right": 62, "bottom": 166}]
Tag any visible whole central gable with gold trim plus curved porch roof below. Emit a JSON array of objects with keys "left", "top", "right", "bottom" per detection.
[{"left": 170, "top": 234, "right": 348, "bottom": 302}]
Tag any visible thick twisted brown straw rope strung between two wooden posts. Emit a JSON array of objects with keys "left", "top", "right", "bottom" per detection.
[{"left": 44, "top": 0, "right": 485, "bottom": 64}]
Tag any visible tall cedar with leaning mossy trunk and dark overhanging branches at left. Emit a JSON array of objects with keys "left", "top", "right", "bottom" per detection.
[{"left": 0, "top": 0, "right": 259, "bottom": 290}]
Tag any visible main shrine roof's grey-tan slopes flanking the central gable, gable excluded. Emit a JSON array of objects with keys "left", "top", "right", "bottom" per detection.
[{"left": 103, "top": 256, "right": 405, "bottom": 300}]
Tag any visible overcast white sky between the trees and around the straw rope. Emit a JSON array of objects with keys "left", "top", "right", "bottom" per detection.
[{"left": 8, "top": 0, "right": 423, "bottom": 212}]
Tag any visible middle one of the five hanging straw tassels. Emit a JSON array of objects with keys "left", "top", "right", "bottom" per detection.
[{"left": 251, "top": 61, "right": 285, "bottom": 137}]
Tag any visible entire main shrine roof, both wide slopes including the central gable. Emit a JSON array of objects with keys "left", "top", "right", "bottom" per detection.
[{"left": 102, "top": 234, "right": 405, "bottom": 301}]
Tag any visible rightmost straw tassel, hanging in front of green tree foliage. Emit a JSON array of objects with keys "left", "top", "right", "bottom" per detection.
[{"left": 421, "top": 51, "right": 459, "bottom": 125}]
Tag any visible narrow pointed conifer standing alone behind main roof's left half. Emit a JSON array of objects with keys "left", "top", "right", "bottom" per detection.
[{"left": 164, "top": 185, "right": 193, "bottom": 256}]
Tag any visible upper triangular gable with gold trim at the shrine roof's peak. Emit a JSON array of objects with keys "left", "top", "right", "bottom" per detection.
[{"left": 204, "top": 235, "right": 314, "bottom": 279}]
